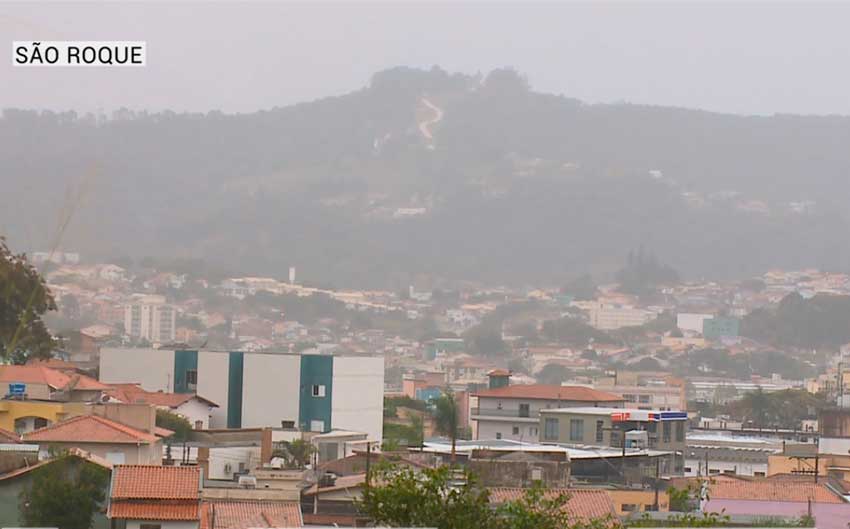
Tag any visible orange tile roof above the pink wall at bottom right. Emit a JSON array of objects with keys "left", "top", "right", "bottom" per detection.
[{"left": 708, "top": 479, "right": 844, "bottom": 503}]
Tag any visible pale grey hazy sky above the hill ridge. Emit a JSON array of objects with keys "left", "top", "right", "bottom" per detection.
[{"left": 0, "top": 1, "right": 850, "bottom": 115}]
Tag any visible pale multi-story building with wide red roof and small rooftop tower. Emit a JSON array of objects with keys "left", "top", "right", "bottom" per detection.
[{"left": 470, "top": 370, "right": 623, "bottom": 441}]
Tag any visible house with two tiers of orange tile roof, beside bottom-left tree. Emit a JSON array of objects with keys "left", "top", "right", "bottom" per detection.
[{"left": 107, "top": 465, "right": 202, "bottom": 529}]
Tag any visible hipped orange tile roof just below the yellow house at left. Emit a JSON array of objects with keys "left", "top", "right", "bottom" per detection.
[{"left": 24, "top": 415, "right": 158, "bottom": 444}]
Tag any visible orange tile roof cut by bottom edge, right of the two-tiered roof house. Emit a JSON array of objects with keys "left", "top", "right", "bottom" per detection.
[{"left": 201, "top": 501, "right": 304, "bottom": 529}]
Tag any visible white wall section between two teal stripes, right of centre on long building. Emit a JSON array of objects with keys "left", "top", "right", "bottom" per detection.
[{"left": 242, "top": 353, "right": 300, "bottom": 428}]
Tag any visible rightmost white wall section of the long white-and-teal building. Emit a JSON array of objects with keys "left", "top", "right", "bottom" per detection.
[{"left": 331, "top": 356, "right": 384, "bottom": 441}]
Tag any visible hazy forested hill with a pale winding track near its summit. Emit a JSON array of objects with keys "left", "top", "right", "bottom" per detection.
[{"left": 0, "top": 68, "right": 850, "bottom": 288}]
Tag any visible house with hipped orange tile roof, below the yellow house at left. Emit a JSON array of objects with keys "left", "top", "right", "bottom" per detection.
[{"left": 23, "top": 415, "right": 162, "bottom": 465}]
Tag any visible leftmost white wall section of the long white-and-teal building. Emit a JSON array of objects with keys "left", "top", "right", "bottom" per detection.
[{"left": 100, "top": 347, "right": 174, "bottom": 393}]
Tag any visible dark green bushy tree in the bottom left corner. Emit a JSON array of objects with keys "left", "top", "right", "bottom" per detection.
[{"left": 19, "top": 456, "right": 109, "bottom": 529}]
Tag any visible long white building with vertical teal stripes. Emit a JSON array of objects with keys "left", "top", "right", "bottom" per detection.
[{"left": 100, "top": 348, "right": 384, "bottom": 440}]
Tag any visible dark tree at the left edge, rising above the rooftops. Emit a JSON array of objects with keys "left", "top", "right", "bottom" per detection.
[{"left": 0, "top": 237, "right": 57, "bottom": 363}]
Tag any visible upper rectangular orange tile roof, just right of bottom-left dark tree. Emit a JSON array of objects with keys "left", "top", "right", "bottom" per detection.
[{"left": 110, "top": 465, "right": 201, "bottom": 500}]
